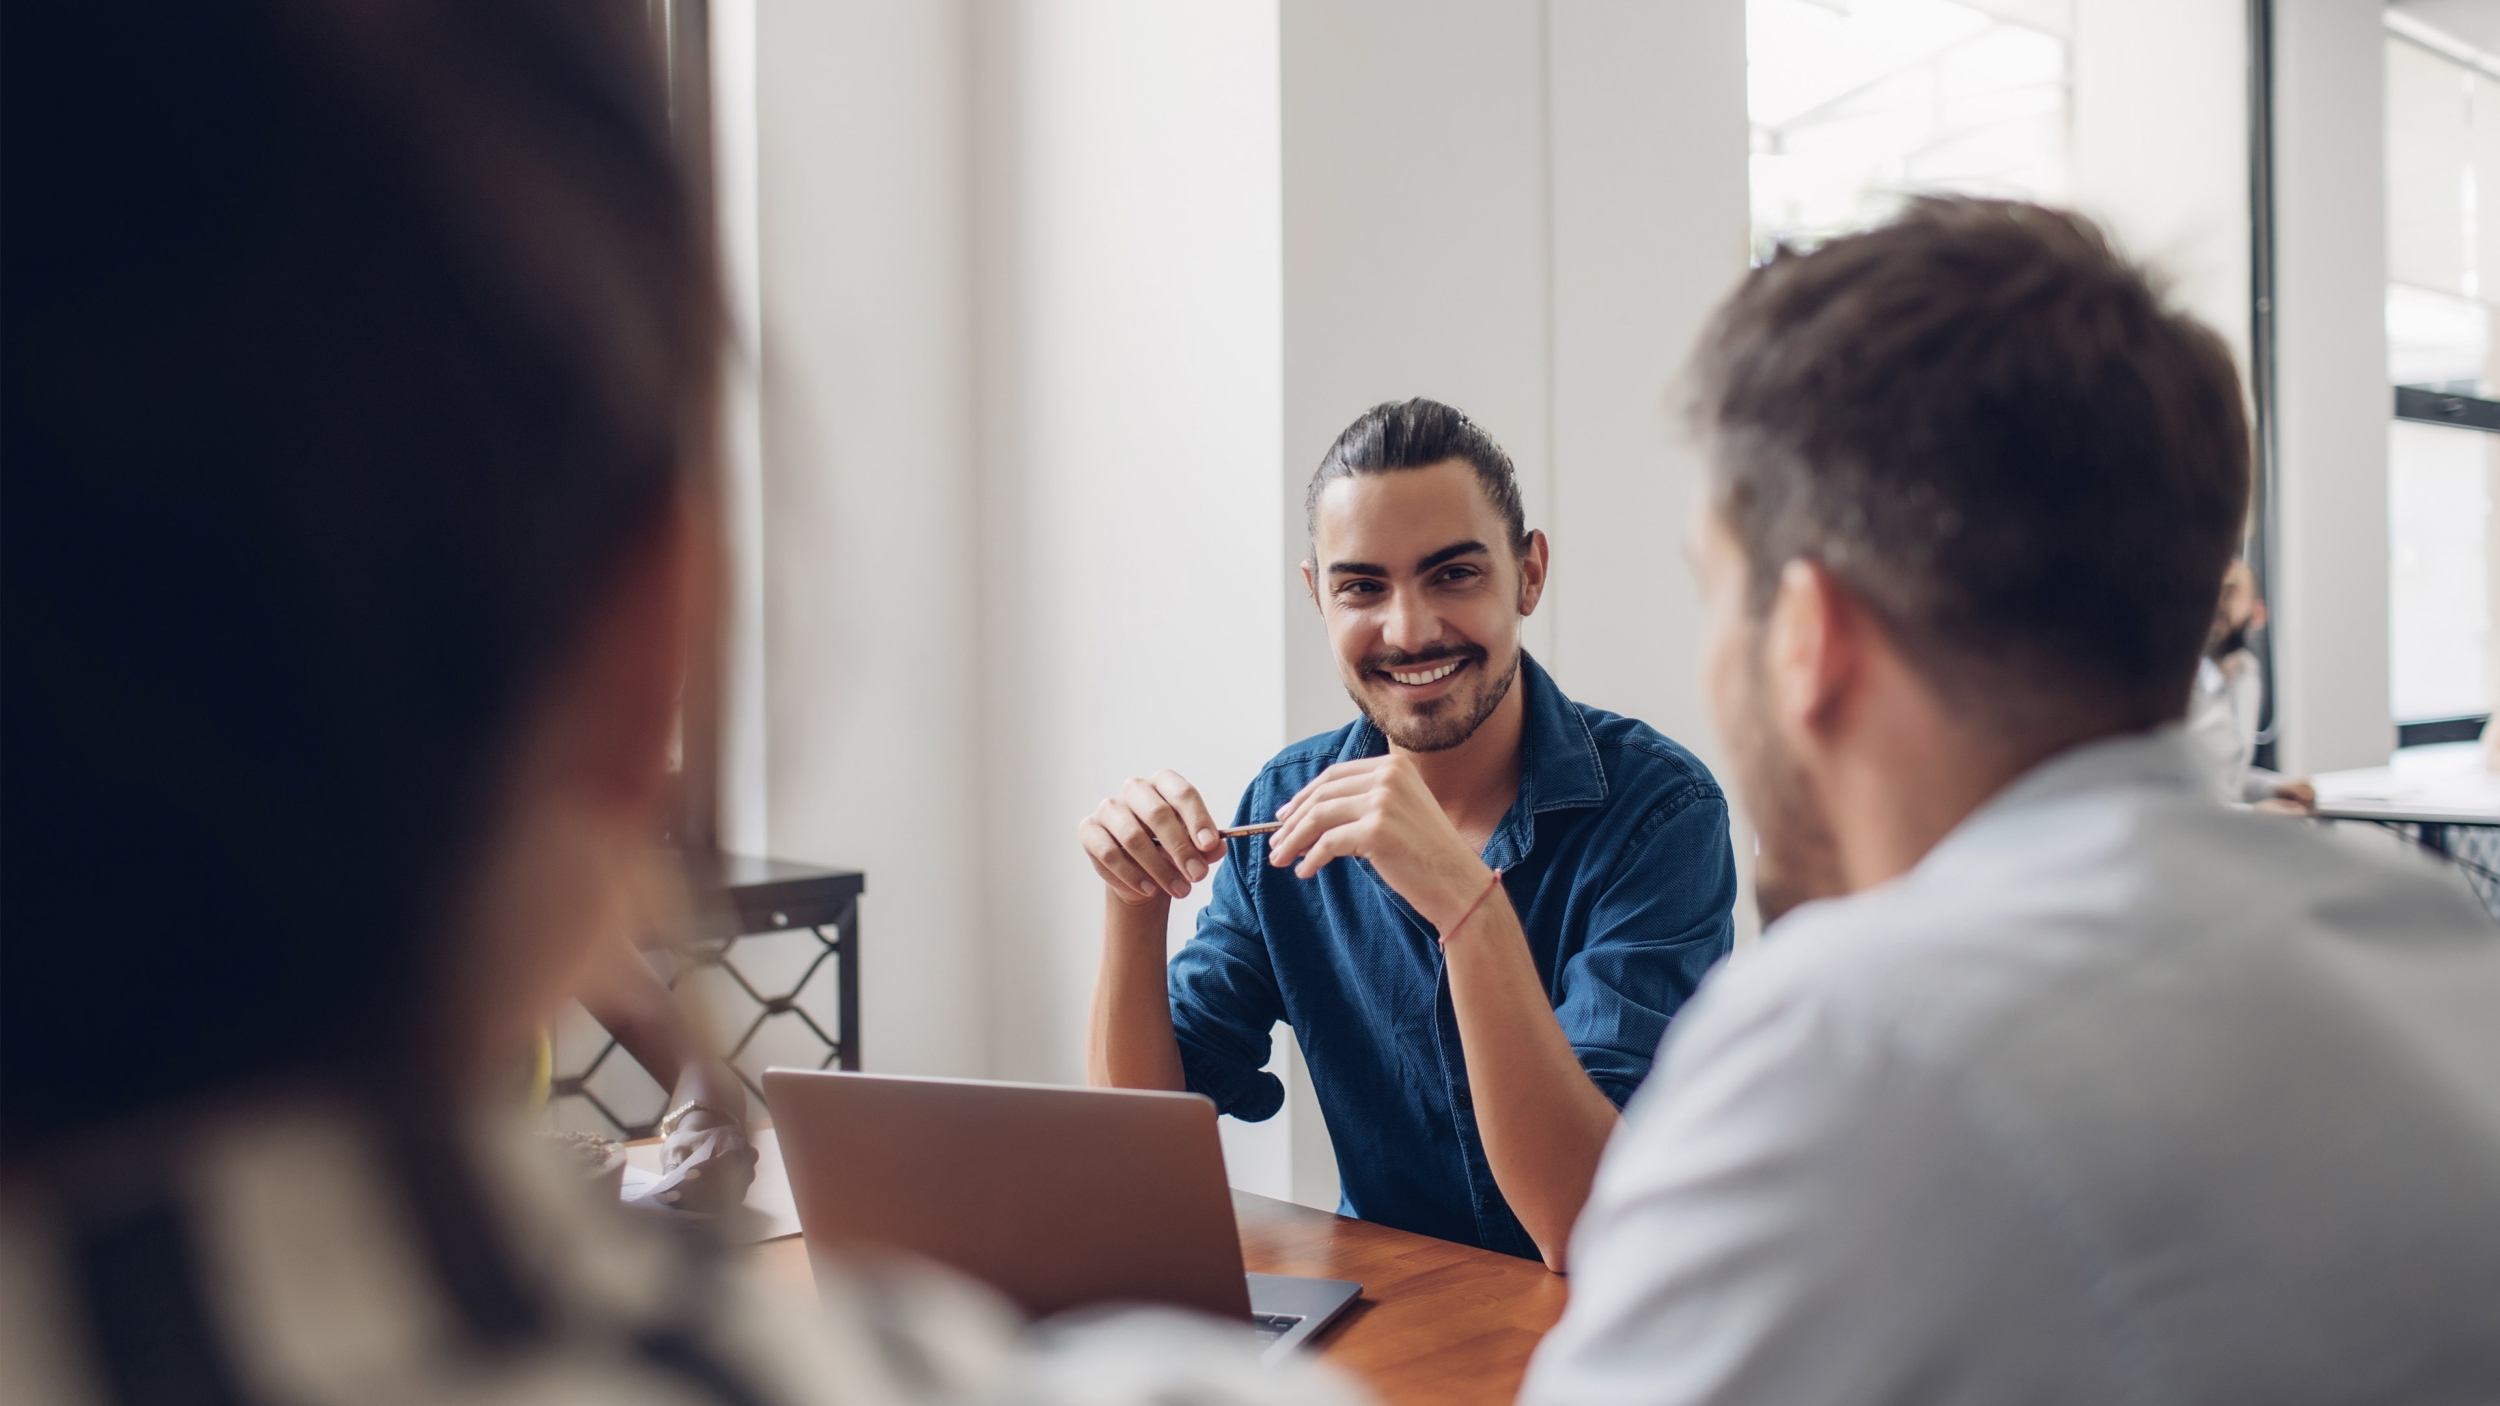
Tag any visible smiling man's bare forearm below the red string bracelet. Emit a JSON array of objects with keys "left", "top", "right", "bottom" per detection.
[{"left": 1445, "top": 891, "right": 1620, "bottom": 1271}]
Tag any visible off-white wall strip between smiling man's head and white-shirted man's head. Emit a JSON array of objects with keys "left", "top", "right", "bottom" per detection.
[{"left": 1548, "top": 0, "right": 1760, "bottom": 941}]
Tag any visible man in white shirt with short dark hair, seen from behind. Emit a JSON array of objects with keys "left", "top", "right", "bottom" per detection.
[{"left": 1525, "top": 200, "right": 2500, "bottom": 1406}]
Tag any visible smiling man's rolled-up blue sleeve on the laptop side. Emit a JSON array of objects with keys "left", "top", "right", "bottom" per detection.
[{"left": 1170, "top": 841, "right": 1285, "bottom": 1123}]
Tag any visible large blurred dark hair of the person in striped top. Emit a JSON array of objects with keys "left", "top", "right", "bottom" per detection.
[{"left": 0, "top": 0, "right": 718, "bottom": 1151}]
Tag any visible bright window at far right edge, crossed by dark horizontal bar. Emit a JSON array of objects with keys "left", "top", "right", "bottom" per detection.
[{"left": 2388, "top": 5, "right": 2500, "bottom": 723}]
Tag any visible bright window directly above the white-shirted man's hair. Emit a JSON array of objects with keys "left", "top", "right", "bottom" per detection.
[{"left": 1745, "top": 0, "right": 2073, "bottom": 260}]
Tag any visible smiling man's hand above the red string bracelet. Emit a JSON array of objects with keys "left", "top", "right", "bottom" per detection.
[{"left": 1268, "top": 753, "right": 1493, "bottom": 936}]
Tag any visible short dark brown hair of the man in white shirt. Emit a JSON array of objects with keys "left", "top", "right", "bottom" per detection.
[{"left": 1695, "top": 200, "right": 2250, "bottom": 726}]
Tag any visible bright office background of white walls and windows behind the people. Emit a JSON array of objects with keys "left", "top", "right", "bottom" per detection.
[{"left": 550, "top": 0, "right": 2500, "bottom": 1208}]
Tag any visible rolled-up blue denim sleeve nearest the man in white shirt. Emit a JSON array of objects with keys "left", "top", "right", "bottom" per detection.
[{"left": 1555, "top": 786, "right": 1735, "bottom": 1108}]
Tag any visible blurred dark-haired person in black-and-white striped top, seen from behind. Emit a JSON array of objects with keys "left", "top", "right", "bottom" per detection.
[{"left": 0, "top": 0, "right": 1350, "bottom": 1406}]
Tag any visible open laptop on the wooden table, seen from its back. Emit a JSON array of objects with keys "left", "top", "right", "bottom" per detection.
[{"left": 765, "top": 1068, "right": 1363, "bottom": 1358}]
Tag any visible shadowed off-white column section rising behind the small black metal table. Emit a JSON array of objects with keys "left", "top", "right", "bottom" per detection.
[{"left": 755, "top": 0, "right": 990, "bottom": 1073}]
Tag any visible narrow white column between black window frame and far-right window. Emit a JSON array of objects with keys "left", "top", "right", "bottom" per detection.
[{"left": 2275, "top": 0, "right": 2395, "bottom": 773}]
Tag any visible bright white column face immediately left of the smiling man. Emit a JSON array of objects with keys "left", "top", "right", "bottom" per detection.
[{"left": 975, "top": 0, "right": 1285, "bottom": 1081}]
